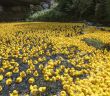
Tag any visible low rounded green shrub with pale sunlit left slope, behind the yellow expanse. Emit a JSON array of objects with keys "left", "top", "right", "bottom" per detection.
[{"left": 29, "top": 9, "right": 67, "bottom": 21}]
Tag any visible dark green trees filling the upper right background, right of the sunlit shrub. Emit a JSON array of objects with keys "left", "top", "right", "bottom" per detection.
[{"left": 57, "top": 0, "right": 110, "bottom": 21}]
